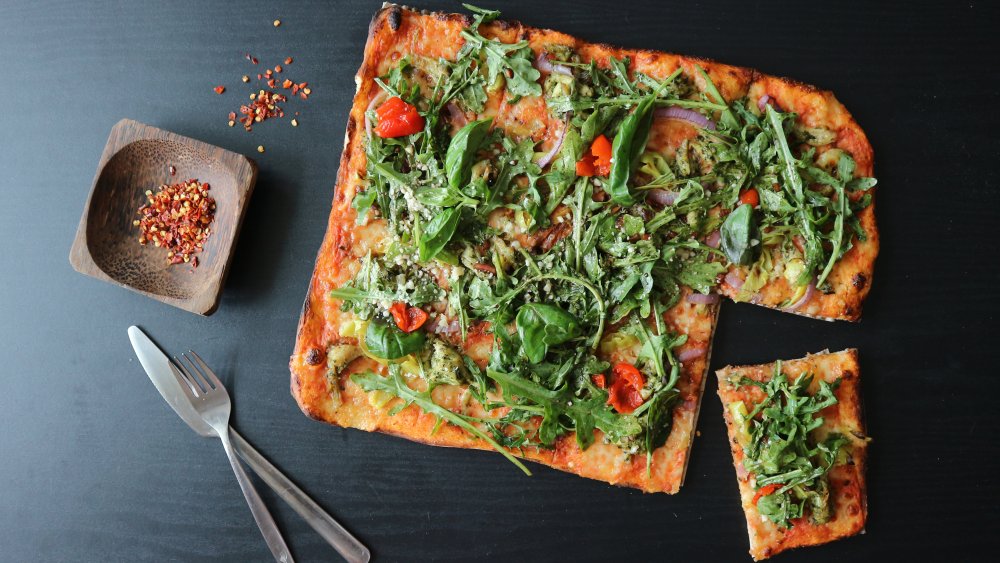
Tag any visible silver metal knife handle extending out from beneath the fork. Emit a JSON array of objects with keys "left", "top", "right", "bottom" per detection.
[{"left": 229, "top": 428, "right": 371, "bottom": 563}]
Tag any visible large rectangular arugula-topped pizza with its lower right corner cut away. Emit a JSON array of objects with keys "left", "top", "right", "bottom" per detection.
[{"left": 290, "top": 5, "right": 878, "bottom": 493}]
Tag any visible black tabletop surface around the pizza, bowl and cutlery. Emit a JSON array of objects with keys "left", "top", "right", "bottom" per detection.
[{"left": 0, "top": 0, "right": 1000, "bottom": 562}]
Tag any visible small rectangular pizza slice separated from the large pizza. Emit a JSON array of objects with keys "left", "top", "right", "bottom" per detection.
[{"left": 716, "top": 349, "right": 869, "bottom": 560}]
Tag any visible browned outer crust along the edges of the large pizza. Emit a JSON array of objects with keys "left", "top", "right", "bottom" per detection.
[{"left": 289, "top": 4, "right": 874, "bottom": 493}]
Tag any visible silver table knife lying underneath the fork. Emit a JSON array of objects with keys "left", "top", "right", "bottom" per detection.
[{"left": 128, "top": 326, "right": 371, "bottom": 563}]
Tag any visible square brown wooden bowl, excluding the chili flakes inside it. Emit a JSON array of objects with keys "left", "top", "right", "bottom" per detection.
[{"left": 69, "top": 119, "right": 257, "bottom": 315}]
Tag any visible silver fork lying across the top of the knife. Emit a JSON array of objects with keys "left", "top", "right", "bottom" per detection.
[{"left": 170, "top": 350, "right": 293, "bottom": 563}]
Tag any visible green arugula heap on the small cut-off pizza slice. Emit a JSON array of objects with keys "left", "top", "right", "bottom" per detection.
[{"left": 738, "top": 362, "right": 848, "bottom": 528}]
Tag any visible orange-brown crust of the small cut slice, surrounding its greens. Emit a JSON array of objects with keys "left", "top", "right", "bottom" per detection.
[{"left": 716, "top": 349, "right": 868, "bottom": 560}]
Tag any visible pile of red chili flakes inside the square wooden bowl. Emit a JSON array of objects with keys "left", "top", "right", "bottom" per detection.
[{"left": 132, "top": 181, "right": 215, "bottom": 268}]
